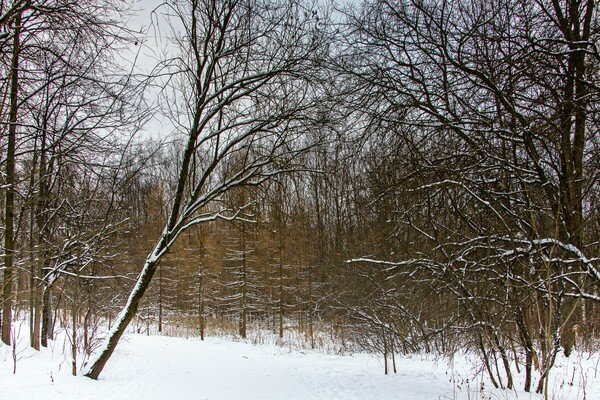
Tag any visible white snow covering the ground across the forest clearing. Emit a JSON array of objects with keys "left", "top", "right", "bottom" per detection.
[{"left": 0, "top": 335, "right": 600, "bottom": 400}]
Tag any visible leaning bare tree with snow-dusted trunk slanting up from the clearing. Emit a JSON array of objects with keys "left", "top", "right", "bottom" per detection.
[{"left": 85, "top": 0, "right": 319, "bottom": 379}]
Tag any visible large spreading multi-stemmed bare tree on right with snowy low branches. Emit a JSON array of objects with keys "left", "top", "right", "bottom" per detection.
[{"left": 337, "top": 0, "right": 599, "bottom": 391}]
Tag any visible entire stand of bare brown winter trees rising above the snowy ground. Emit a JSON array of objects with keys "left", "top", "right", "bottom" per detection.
[{"left": 0, "top": 0, "right": 600, "bottom": 392}]
